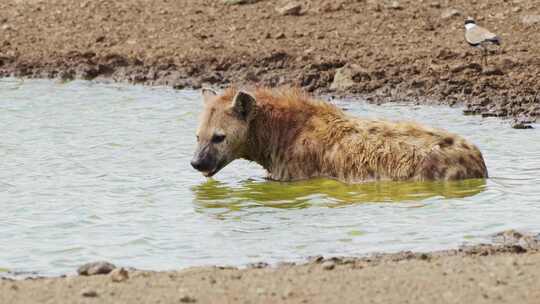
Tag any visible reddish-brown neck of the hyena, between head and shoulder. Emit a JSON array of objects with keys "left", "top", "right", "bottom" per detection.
[{"left": 244, "top": 105, "right": 311, "bottom": 180}]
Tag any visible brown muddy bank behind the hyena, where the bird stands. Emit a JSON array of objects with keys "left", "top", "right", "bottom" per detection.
[{"left": 0, "top": 0, "right": 540, "bottom": 121}]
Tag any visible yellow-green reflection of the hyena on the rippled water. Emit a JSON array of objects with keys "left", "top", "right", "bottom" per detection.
[{"left": 191, "top": 179, "right": 486, "bottom": 211}]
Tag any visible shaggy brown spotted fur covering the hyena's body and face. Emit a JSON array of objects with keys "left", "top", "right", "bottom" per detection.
[{"left": 194, "top": 88, "right": 487, "bottom": 183}]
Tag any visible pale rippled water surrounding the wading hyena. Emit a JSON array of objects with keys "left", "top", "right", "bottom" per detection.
[{"left": 0, "top": 79, "right": 540, "bottom": 276}]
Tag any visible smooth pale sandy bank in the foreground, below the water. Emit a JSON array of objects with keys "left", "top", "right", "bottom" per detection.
[{"left": 0, "top": 231, "right": 540, "bottom": 304}]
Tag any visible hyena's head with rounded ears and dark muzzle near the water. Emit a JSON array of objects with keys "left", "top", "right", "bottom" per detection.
[{"left": 191, "top": 89, "right": 255, "bottom": 177}]
